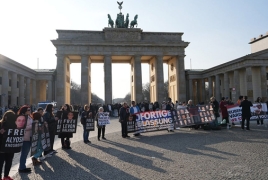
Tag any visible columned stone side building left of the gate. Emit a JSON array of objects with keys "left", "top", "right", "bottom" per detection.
[{"left": 0, "top": 54, "right": 56, "bottom": 107}]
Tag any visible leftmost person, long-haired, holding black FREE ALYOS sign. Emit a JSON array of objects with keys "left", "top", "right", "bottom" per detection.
[{"left": 0, "top": 110, "right": 16, "bottom": 180}]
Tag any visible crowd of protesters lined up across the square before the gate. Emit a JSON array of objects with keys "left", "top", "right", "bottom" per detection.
[{"left": 0, "top": 96, "right": 267, "bottom": 180}]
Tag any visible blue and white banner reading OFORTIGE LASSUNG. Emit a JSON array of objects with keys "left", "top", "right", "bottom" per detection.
[{"left": 136, "top": 110, "right": 174, "bottom": 132}]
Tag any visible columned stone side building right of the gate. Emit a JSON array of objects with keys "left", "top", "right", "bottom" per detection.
[{"left": 185, "top": 32, "right": 268, "bottom": 103}]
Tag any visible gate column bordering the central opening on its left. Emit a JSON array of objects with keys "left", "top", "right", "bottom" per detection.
[{"left": 104, "top": 55, "right": 113, "bottom": 104}]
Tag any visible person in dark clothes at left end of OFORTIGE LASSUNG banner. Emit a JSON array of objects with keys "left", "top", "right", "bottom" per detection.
[{"left": 119, "top": 102, "right": 130, "bottom": 138}]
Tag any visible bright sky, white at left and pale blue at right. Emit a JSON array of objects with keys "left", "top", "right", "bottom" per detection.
[{"left": 0, "top": 0, "right": 268, "bottom": 100}]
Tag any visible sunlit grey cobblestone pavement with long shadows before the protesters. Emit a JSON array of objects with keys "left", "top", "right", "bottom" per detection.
[{"left": 13, "top": 125, "right": 268, "bottom": 180}]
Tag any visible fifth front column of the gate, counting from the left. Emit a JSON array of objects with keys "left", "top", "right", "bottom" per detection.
[{"left": 155, "top": 56, "right": 166, "bottom": 103}]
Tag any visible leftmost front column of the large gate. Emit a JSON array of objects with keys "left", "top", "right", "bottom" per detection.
[{"left": 55, "top": 54, "right": 66, "bottom": 107}]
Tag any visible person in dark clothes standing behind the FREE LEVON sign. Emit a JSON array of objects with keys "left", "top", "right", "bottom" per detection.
[{"left": 59, "top": 104, "right": 73, "bottom": 149}]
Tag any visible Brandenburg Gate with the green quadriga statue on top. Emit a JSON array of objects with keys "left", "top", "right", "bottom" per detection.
[{"left": 52, "top": 3, "right": 189, "bottom": 105}]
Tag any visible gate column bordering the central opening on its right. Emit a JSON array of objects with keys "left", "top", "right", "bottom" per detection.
[{"left": 133, "top": 55, "right": 143, "bottom": 103}]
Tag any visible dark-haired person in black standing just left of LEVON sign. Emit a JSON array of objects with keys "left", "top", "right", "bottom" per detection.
[{"left": 43, "top": 104, "right": 59, "bottom": 157}]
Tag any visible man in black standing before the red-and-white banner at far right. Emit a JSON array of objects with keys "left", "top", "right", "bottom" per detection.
[{"left": 239, "top": 96, "right": 253, "bottom": 130}]
